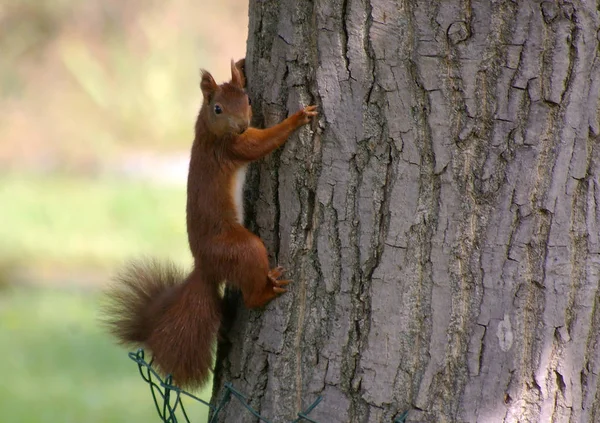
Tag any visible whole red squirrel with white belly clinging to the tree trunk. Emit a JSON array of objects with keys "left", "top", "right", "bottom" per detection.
[{"left": 105, "top": 59, "right": 317, "bottom": 388}]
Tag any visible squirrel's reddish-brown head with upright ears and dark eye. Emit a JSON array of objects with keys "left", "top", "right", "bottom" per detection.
[{"left": 200, "top": 61, "right": 252, "bottom": 137}]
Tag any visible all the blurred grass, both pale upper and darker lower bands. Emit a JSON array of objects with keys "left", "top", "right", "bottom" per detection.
[{"left": 0, "top": 174, "right": 210, "bottom": 423}]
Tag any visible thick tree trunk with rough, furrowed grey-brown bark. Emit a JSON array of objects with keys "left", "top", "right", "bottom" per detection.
[{"left": 215, "top": 0, "right": 600, "bottom": 423}]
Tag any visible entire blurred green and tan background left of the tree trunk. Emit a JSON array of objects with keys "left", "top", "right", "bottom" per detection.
[{"left": 0, "top": 0, "right": 247, "bottom": 423}]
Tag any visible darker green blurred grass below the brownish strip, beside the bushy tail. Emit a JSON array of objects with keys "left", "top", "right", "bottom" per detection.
[{"left": 0, "top": 287, "right": 210, "bottom": 423}]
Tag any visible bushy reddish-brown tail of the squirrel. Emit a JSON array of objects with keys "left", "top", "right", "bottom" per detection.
[{"left": 104, "top": 261, "right": 221, "bottom": 388}]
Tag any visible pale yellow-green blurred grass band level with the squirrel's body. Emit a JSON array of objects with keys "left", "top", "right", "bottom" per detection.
[{"left": 0, "top": 174, "right": 190, "bottom": 273}]
